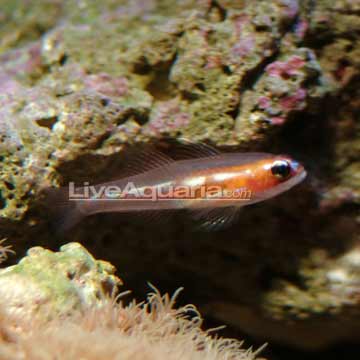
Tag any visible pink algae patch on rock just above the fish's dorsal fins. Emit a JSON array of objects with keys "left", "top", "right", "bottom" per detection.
[{"left": 148, "top": 100, "right": 190, "bottom": 134}]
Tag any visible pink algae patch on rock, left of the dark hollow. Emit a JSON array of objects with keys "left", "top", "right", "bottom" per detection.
[{"left": 84, "top": 73, "right": 128, "bottom": 97}]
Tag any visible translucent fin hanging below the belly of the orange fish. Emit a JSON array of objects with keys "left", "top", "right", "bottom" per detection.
[{"left": 191, "top": 206, "right": 240, "bottom": 231}]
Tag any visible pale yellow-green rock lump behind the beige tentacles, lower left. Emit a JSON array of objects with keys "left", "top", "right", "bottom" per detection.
[{"left": 0, "top": 243, "right": 121, "bottom": 321}]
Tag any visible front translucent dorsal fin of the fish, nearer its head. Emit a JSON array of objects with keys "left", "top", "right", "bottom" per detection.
[{"left": 167, "top": 138, "right": 221, "bottom": 160}]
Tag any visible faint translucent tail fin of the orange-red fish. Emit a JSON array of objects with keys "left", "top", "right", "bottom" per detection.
[{"left": 44, "top": 188, "right": 85, "bottom": 234}]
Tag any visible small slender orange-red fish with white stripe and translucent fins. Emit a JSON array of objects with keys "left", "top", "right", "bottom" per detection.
[{"left": 50, "top": 144, "right": 306, "bottom": 230}]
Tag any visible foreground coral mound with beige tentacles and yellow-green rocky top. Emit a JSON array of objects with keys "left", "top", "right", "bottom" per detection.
[{"left": 0, "top": 244, "right": 261, "bottom": 360}]
